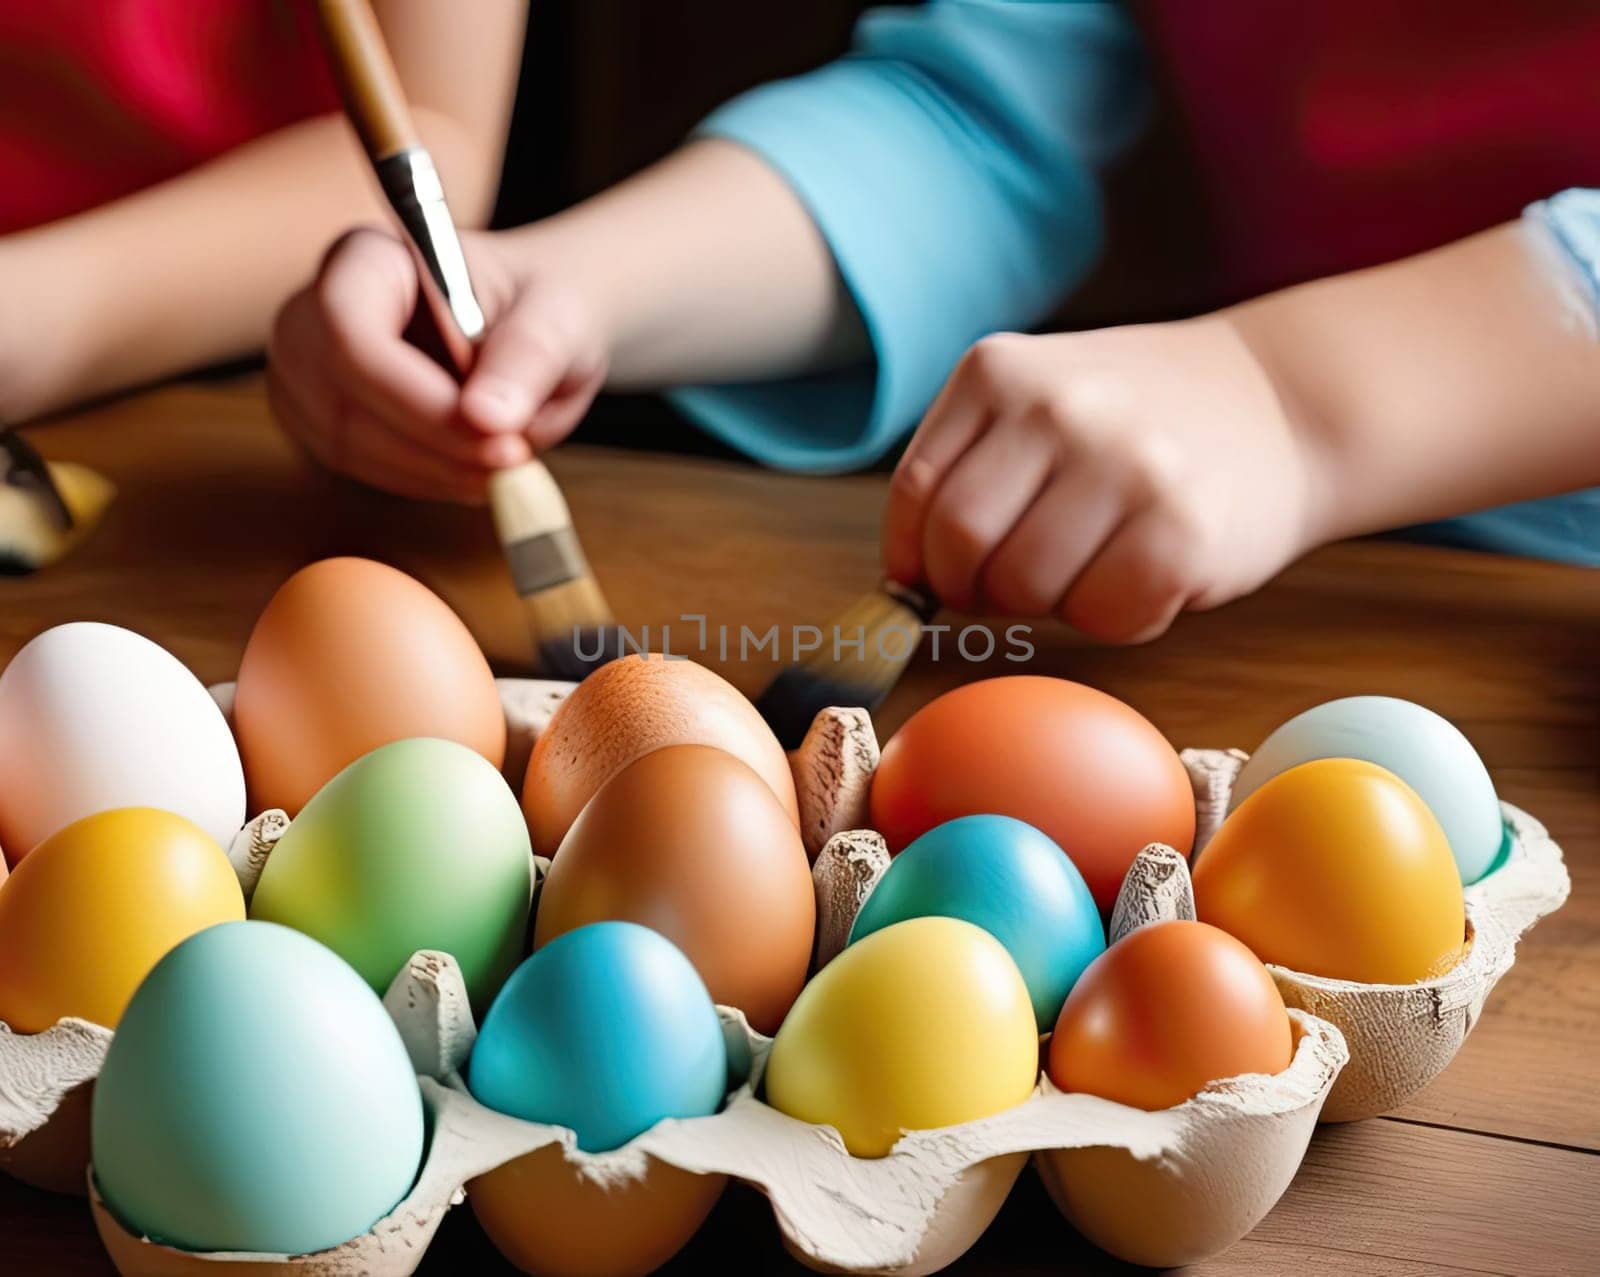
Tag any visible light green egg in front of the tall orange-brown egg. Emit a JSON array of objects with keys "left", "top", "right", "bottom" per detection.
[{"left": 250, "top": 738, "right": 533, "bottom": 1015}]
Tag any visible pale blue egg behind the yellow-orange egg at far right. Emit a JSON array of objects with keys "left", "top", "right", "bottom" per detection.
[{"left": 1229, "top": 696, "right": 1506, "bottom": 883}]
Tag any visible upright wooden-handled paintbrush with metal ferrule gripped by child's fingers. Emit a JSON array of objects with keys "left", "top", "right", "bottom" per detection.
[{"left": 317, "top": 0, "right": 621, "bottom": 679}]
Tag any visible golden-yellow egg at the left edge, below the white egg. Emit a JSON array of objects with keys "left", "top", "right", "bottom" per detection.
[{"left": 0, "top": 807, "right": 245, "bottom": 1034}]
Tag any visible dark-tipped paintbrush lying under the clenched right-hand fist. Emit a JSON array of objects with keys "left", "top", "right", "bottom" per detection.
[{"left": 755, "top": 581, "right": 939, "bottom": 749}]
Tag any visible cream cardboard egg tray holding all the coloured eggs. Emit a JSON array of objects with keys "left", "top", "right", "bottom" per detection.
[{"left": 0, "top": 680, "right": 1568, "bottom": 1277}]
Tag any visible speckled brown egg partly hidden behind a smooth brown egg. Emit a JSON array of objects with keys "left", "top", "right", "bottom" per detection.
[{"left": 522, "top": 655, "right": 800, "bottom": 856}]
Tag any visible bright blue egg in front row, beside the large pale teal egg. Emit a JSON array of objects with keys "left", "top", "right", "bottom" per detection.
[{"left": 467, "top": 922, "right": 728, "bottom": 1152}]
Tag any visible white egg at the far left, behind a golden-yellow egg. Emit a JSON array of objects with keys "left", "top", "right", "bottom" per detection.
[{"left": 0, "top": 621, "right": 245, "bottom": 861}]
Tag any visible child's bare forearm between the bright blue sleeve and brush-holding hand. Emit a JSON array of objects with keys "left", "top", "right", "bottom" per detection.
[{"left": 507, "top": 141, "right": 867, "bottom": 387}]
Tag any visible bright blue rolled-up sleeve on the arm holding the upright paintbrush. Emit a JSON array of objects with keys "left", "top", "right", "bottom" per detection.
[{"left": 674, "top": 0, "right": 1147, "bottom": 472}]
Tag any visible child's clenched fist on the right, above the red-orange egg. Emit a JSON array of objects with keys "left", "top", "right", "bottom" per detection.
[{"left": 883, "top": 317, "right": 1318, "bottom": 642}]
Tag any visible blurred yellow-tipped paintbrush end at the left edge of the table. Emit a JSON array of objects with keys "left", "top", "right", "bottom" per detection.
[{"left": 0, "top": 426, "right": 117, "bottom": 576}]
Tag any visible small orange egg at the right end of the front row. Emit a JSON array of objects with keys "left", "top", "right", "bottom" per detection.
[{"left": 1050, "top": 920, "right": 1293, "bottom": 1109}]
